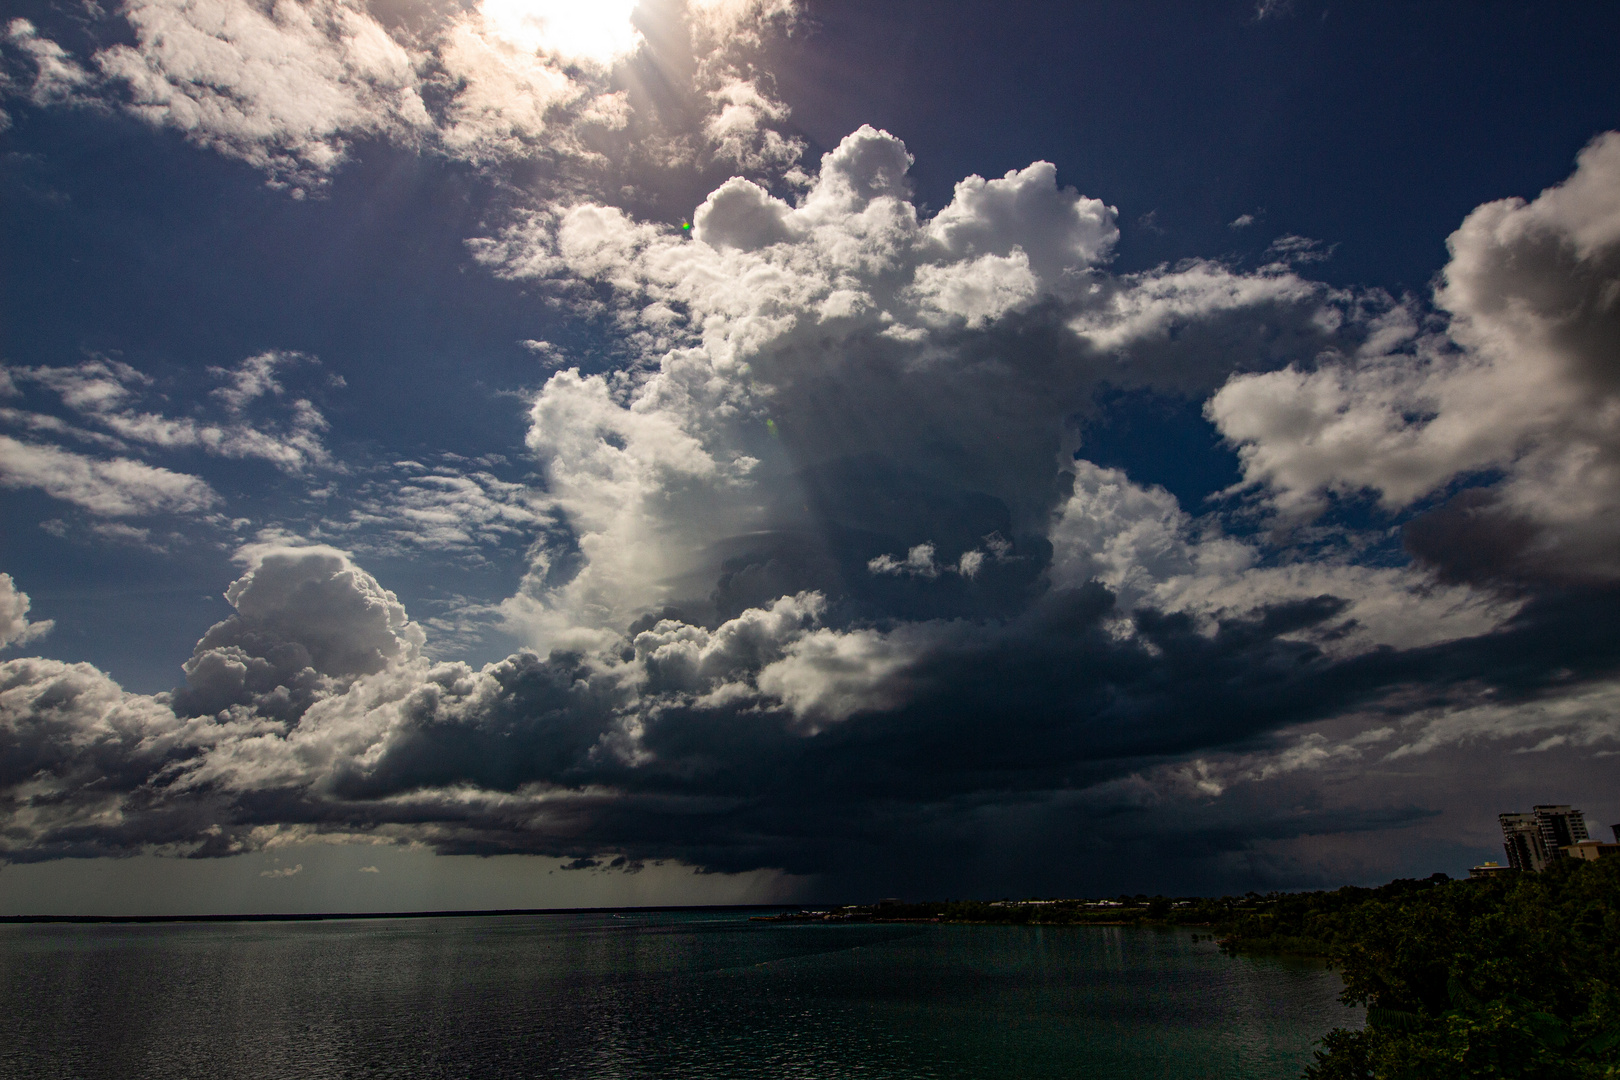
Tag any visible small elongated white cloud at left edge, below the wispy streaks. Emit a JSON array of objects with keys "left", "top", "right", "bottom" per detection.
[{"left": 0, "top": 436, "right": 220, "bottom": 517}]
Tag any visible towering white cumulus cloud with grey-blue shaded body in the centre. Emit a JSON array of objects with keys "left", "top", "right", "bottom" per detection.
[{"left": 473, "top": 128, "right": 1338, "bottom": 648}]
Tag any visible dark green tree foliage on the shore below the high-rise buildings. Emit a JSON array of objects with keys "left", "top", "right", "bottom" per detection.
[{"left": 1228, "top": 858, "right": 1620, "bottom": 1080}]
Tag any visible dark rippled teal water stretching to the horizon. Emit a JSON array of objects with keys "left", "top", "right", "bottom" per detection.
[{"left": 0, "top": 912, "right": 1361, "bottom": 1080}]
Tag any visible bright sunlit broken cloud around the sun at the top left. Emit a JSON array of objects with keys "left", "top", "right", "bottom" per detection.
[{"left": 8, "top": 0, "right": 804, "bottom": 187}]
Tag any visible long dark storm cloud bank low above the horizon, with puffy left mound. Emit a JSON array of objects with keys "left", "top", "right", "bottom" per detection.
[{"left": 0, "top": 531, "right": 1620, "bottom": 881}]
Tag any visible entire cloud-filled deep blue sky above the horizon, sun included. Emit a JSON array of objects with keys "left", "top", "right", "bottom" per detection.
[{"left": 0, "top": 0, "right": 1620, "bottom": 915}]
